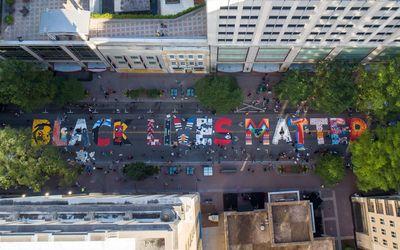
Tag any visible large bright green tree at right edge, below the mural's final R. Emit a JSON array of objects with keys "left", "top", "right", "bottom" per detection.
[{"left": 350, "top": 123, "right": 400, "bottom": 191}]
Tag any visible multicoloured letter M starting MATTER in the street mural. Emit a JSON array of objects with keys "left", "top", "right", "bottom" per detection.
[{"left": 244, "top": 118, "right": 269, "bottom": 145}]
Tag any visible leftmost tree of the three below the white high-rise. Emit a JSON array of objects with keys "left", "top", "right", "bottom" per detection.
[{"left": 274, "top": 70, "right": 312, "bottom": 107}]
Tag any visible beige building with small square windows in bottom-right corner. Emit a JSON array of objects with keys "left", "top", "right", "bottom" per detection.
[{"left": 352, "top": 196, "right": 400, "bottom": 250}]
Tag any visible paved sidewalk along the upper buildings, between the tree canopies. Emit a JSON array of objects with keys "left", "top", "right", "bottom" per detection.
[{"left": 83, "top": 72, "right": 281, "bottom": 103}]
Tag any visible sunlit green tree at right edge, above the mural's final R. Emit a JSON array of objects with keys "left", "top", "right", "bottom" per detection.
[{"left": 356, "top": 57, "right": 400, "bottom": 121}]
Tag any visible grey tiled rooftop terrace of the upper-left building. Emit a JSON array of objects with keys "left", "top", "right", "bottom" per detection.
[{"left": 2, "top": 0, "right": 207, "bottom": 41}]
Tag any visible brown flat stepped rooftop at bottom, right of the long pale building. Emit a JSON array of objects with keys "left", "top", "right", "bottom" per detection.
[{"left": 223, "top": 201, "right": 334, "bottom": 250}]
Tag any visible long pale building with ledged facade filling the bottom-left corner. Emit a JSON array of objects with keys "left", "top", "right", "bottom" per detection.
[{"left": 0, "top": 194, "right": 202, "bottom": 250}]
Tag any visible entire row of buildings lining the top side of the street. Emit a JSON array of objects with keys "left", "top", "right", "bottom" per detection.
[{"left": 0, "top": 0, "right": 400, "bottom": 73}]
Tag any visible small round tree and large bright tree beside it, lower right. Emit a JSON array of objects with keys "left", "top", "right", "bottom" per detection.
[{"left": 315, "top": 123, "right": 400, "bottom": 192}]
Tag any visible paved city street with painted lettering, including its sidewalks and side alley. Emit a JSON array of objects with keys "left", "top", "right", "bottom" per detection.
[{"left": 0, "top": 72, "right": 365, "bottom": 246}]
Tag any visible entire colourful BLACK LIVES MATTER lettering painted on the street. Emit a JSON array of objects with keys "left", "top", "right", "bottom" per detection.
[{"left": 31, "top": 115, "right": 367, "bottom": 149}]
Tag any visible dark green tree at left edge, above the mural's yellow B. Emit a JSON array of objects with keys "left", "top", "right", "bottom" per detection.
[{"left": 0, "top": 60, "right": 57, "bottom": 111}]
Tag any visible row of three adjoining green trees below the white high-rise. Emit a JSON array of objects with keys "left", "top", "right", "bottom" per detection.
[{"left": 274, "top": 57, "right": 400, "bottom": 121}]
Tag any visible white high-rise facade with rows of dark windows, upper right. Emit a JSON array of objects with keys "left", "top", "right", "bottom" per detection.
[{"left": 207, "top": 0, "right": 400, "bottom": 72}]
